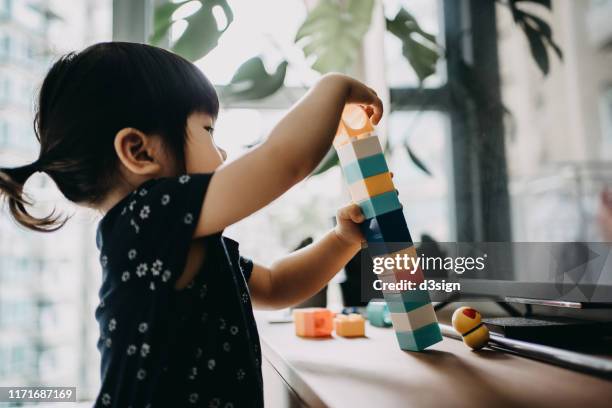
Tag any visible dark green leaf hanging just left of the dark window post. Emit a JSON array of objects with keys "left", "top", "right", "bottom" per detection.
[{"left": 387, "top": 7, "right": 440, "bottom": 82}]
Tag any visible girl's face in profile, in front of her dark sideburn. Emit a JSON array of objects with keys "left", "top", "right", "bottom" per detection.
[{"left": 185, "top": 113, "right": 227, "bottom": 173}]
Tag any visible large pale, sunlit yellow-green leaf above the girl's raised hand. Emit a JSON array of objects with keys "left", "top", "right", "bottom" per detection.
[{"left": 295, "top": 0, "right": 374, "bottom": 73}]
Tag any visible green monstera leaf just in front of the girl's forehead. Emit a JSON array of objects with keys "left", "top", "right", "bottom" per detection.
[{"left": 220, "top": 57, "right": 287, "bottom": 101}]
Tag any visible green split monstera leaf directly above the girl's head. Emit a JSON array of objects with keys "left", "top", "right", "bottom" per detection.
[{"left": 149, "top": 0, "right": 234, "bottom": 61}]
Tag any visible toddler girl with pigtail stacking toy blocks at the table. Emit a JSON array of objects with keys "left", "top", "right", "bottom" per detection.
[{"left": 0, "top": 42, "right": 382, "bottom": 407}]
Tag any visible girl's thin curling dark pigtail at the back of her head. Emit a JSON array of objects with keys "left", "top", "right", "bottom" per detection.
[{"left": 0, "top": 162, "right": 66, "bottom": 232}]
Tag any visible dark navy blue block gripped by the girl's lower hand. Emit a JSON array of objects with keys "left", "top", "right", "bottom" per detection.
[{"left": 359, "top": 208, "right": 412, "bottom": 256}]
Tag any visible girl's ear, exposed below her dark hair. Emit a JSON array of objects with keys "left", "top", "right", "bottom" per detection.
[{"left": 115, "top": 128, "right": 162, "bottom": 176}]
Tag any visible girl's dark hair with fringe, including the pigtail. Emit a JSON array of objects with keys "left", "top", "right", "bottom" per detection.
[{"left": 0, "top": 42, "right": 219, "bottom": 231}]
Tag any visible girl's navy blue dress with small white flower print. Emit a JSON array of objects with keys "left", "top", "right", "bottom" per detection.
[{"left": 95, "top": 174, "right": 263, "bottom": 408}]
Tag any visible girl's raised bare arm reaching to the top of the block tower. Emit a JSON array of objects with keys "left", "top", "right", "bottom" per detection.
[{"left": 195, "top": 74, "right": 383, "bottom": 237}]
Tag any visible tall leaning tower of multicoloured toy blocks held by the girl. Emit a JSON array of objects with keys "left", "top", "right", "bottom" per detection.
[{"left": 334, "top": 105, "right": 442, "bottom": 351}]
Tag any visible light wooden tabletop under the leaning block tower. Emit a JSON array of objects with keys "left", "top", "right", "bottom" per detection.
[{"left": 257, "top": 315, "right": 612, "bottom": 408}]
